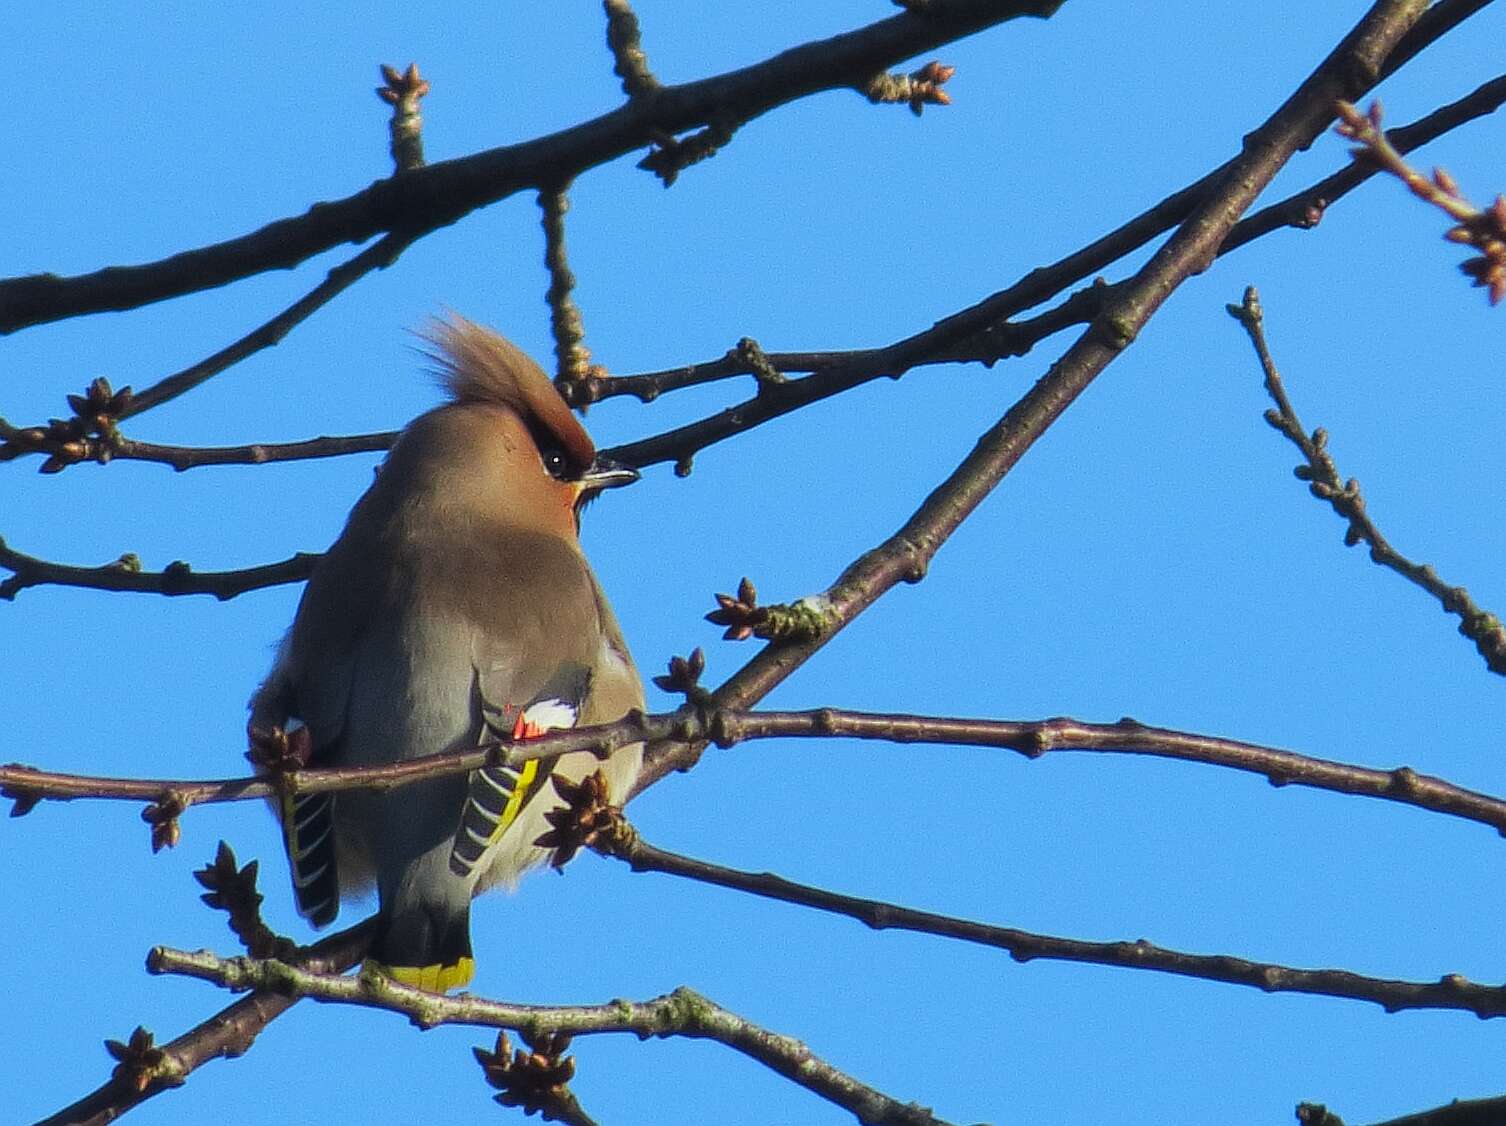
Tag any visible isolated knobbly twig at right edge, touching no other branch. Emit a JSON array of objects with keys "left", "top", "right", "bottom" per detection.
[{"left": 1227, "top": 286, "right": 1506, "bottom": 676}]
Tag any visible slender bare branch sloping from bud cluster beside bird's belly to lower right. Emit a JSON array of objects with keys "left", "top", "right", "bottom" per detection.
[{"left": 619, "top": 840, "right": 1506, "bottom": 1018}]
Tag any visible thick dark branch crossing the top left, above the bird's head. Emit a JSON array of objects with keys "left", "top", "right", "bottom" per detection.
[{"left": 0, "top": 0, "right": 1060, "bottom": 334}]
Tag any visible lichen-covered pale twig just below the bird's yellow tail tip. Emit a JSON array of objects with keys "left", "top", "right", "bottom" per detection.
[{"left": 146, "top": 947, "right": 944, "bottom": 1126}]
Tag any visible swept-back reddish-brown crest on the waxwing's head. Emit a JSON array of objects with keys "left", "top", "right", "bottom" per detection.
[{"left": 423, "top": 313, "right": 596, "bottom": 468}]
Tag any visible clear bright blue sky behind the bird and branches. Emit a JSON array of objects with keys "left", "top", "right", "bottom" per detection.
[{"left": 0, "top": 0, "right": 1506, "bottom": 1124}]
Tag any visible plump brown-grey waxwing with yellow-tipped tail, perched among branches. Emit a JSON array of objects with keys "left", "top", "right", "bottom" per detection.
[{"left": 250, "top": 318, "right": 643, "bottom": 991}]
